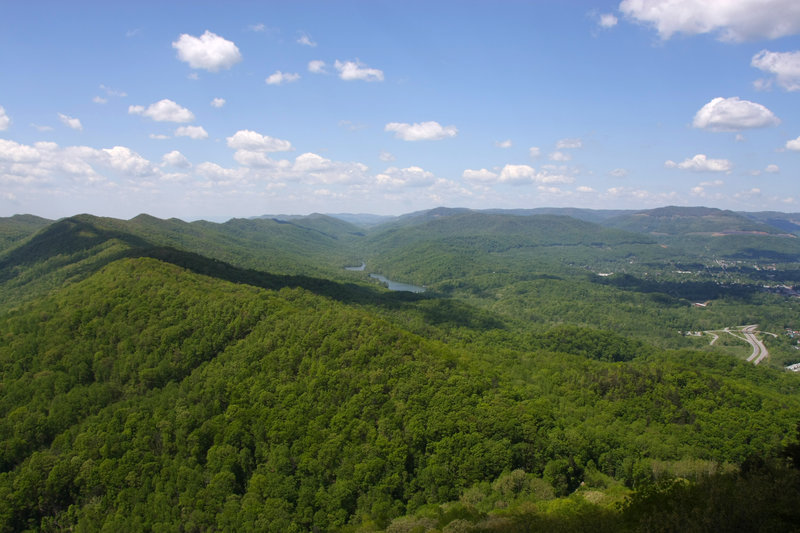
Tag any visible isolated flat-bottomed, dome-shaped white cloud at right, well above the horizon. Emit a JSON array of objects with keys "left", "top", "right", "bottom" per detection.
[{"left": 692, "top": 96, "right": 781, "bottom": 131}]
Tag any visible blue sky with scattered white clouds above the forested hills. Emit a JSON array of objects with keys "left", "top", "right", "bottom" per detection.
[{"left": 0, "top": 0, "right": 800, "bottom": 220}]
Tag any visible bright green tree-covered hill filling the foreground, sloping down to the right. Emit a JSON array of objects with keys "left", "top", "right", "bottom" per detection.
[{"left": 0, "top": 258, "right": 800, "bottom": 531}]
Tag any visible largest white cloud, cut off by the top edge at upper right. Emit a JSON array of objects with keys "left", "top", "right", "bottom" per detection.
[{"left": 619, "top": 0, "right": 800, "bottom": 42}]
